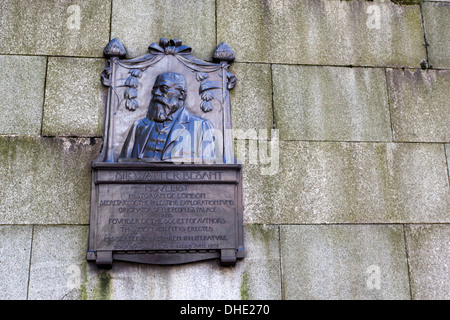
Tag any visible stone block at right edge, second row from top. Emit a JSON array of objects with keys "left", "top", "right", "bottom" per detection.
[{"left": 386, "top": 69, "right": 450, "bottom": 142}]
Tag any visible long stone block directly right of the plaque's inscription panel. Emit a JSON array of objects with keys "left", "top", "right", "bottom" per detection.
[{"left": 243, "top": 141, "right": 450, "bottom": 224}]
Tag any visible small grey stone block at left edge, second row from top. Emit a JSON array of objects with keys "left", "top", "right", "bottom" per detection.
[{"left": 0, "top": 55, "right": 46, "bottom": 135}]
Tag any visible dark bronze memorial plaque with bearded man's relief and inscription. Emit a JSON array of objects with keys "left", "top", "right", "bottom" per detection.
[{"left": 87, "top": 39, "right": 245, "bottom": 268}]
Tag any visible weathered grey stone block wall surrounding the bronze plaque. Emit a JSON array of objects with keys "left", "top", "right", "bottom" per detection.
[{"left": 0, "top": 0, "right": 450, "bottom": 299}]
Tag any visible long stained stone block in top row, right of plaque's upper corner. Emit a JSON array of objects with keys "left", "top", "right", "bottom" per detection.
[{"left": 217, "top": 0, "right": 426, "bottom": 67}]
